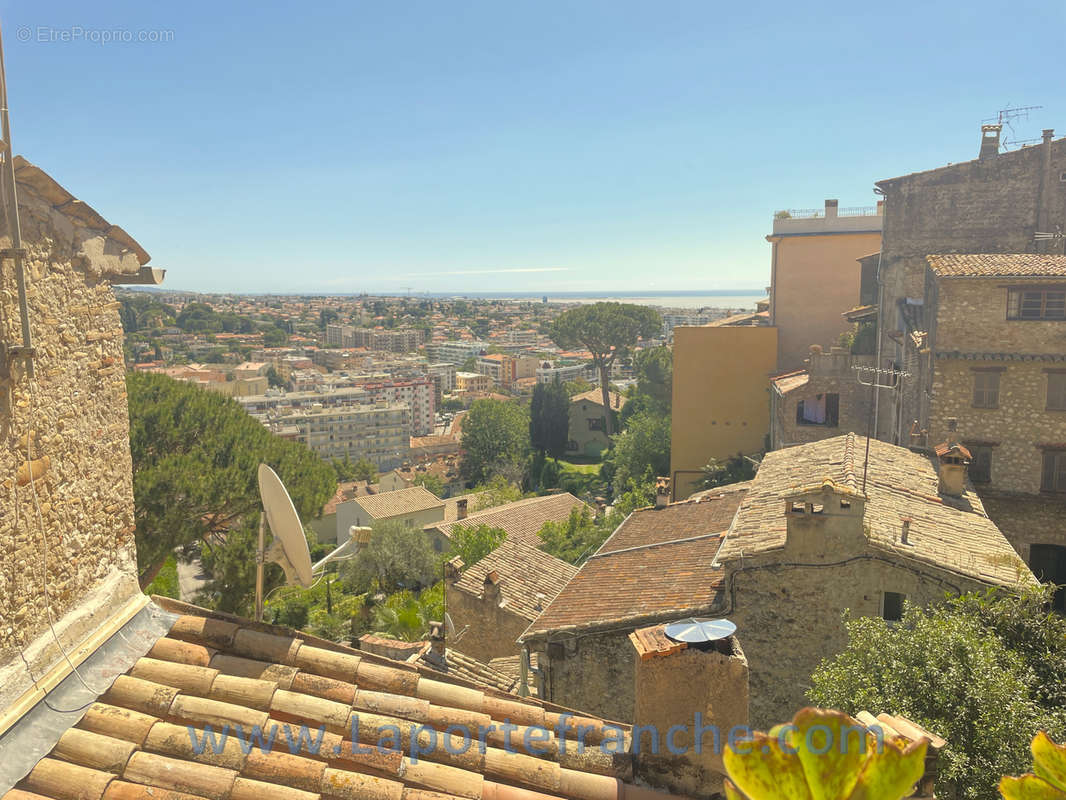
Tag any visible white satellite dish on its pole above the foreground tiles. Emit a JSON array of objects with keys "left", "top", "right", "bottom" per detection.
[{"left": 256, "top": 464, "right": 371, "bottom": 622}]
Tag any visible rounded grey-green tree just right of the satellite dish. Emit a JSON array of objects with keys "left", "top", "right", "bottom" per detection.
[{"left": 340, "top": 519, "right": 439, "bottom": 594}]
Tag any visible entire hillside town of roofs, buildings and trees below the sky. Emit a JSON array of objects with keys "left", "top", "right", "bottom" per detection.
[{"left": 0, "top": 10, "right": 1066, "bottom": 800}]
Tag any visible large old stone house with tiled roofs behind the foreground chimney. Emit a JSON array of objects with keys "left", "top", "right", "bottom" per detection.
[{"left": 521, "top": 434, "right": 1035, "bottom": 726}]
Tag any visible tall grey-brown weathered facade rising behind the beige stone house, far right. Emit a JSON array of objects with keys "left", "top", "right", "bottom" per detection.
[{"left": 877, "top": 131, "right": 1066, "bottom": 445}]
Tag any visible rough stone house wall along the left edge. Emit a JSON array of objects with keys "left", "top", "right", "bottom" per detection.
[{"left": 0, "top": 159, "right": 148, "bottom": 708}]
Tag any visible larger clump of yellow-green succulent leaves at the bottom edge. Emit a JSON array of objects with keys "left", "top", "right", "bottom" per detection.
[{"left": 723, "top": 708, "right": 927, "bottom": 800}]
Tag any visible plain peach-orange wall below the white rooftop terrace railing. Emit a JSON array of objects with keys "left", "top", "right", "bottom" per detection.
[{"left": 768, "top": 233, "right": 881, "bottom": 370}]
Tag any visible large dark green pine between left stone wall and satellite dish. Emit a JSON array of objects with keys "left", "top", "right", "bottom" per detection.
[{"left": 126, "top": 372, "right": 336, "bottom": 608}]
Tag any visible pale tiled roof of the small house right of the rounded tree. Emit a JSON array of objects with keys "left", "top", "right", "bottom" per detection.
[{"left": 455, "top": 538, "right": 578, "bottom": 622}]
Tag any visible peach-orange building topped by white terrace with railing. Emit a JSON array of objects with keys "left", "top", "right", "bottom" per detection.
[{"left": 766, "top": 199, "right": 883, "bottom": 371}]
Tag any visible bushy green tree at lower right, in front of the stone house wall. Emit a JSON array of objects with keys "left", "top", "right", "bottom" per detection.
[{"left": 809, "top": 589, "right": 1066, "bottom": 800}]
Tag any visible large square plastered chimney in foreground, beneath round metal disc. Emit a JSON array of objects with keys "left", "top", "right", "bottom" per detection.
[{"left": 629, "top": 625, "right": 748, "bottom": 797}]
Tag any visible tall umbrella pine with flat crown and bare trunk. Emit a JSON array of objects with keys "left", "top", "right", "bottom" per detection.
[{"left": 551, "top": 303, "right": 662, "bottom": 435}]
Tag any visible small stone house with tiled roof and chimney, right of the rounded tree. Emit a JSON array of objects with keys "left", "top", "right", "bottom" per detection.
[{"left": 445, "top": 537, "right": 578, "bottom": 661}]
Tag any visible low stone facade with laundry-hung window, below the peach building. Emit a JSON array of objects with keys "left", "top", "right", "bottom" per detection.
[{"left": 770, "top": 347, "right": 874, "bottom": 450}]
